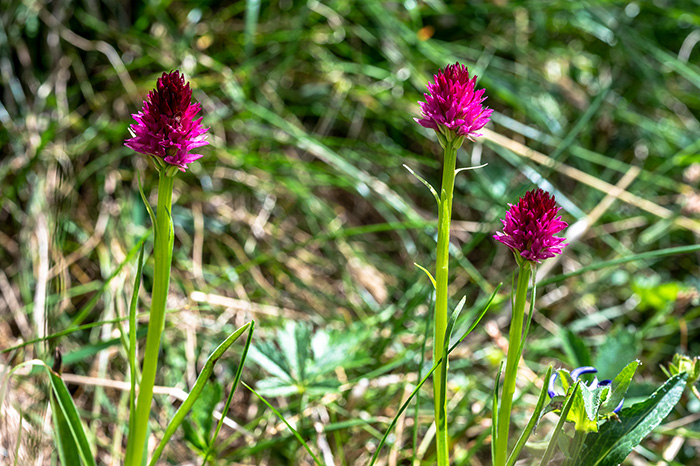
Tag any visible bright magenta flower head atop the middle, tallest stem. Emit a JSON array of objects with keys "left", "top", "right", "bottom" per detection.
[{"left": 414, "top": 62, "right": 493, "bottom": 141}]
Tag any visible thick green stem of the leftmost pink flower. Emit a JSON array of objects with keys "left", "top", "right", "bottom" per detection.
[{"left": 125, "top": 170, "right": 175, "bottom": 466}]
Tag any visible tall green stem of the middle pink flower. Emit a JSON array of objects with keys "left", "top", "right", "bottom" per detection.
[{"left": 433, "top": 138, "right": 463, "bottom": 466}]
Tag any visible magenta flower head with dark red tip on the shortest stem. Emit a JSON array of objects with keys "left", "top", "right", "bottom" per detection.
[{"left": 493, "top": 188, "right": 569, "bottom": 263}]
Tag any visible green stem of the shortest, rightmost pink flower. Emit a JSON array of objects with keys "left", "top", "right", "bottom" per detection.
[{"left": 493, "top": 260, "right": 534, "bottom": 466}]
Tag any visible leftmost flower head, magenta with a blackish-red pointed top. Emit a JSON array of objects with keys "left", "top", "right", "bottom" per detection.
[{"left": 124, "top": 70, "right": 209, "bottom": 172}]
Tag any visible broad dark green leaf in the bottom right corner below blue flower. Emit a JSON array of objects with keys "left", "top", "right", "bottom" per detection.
[{"left": 577, "top": 372, "right": 688, "bottom": 466}]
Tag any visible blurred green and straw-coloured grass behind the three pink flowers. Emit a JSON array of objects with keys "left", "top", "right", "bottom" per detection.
[{"left": 0, "top": 0, "right": 700, "bottom": 466}]
